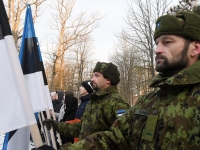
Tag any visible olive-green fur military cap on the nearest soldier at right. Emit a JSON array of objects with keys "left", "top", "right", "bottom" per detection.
[{"left": 154, "top": 11, "right": 200, "bottom": 41}]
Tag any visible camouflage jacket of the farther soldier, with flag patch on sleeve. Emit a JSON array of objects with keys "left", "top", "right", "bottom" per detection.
[{"left": 58, "top": 86, "right": 130, "bottom": 139}]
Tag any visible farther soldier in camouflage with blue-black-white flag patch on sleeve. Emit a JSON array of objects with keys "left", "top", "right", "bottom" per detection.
[{"left": 44, "top": 62, "right": 130, "bottom": 148}]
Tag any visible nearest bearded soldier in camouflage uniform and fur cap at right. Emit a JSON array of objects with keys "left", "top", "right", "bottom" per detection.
[{"left": 48, "top": 12, "right": 200, "bottom": 150}]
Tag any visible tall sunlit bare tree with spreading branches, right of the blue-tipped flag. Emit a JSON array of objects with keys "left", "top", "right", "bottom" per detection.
[{"left": 47, "top": 0, "right": 102, "bottom": 90}]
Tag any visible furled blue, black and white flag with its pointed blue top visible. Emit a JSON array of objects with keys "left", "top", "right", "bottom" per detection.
[{"left": 19, "top": 4, "right": 53, "bottom": 112}]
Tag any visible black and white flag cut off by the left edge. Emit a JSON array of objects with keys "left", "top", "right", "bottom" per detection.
[{"left": 0, "top": 0, "right": 36, "bottom": 134}]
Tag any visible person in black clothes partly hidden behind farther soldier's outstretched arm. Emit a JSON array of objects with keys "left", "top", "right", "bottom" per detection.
[{"left": 60, "top": 91, "right": 78, "bottom": 144}]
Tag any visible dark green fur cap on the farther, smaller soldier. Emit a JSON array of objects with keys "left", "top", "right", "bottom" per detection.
[{"left": 93, "top": 62, "right": 120, "bottom": 85}]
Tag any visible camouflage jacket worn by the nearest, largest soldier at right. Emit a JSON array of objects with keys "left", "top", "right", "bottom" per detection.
[{"left": 62, "top": 61, "right": 200, "bottom": 150}]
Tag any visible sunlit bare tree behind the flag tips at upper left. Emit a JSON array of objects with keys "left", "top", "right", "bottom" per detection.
[{"left": 5, "top": 0, "right": 46, "bottom": 51}]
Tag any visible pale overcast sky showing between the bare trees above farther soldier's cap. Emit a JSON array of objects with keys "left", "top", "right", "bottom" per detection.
[{"left": 35, "top": 0, "right": 178, "bottom": 62}]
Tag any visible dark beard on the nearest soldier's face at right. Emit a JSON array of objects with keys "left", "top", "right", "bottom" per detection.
[{"left": 155, "top": 41, "right": 190, "bottom": 75}]
